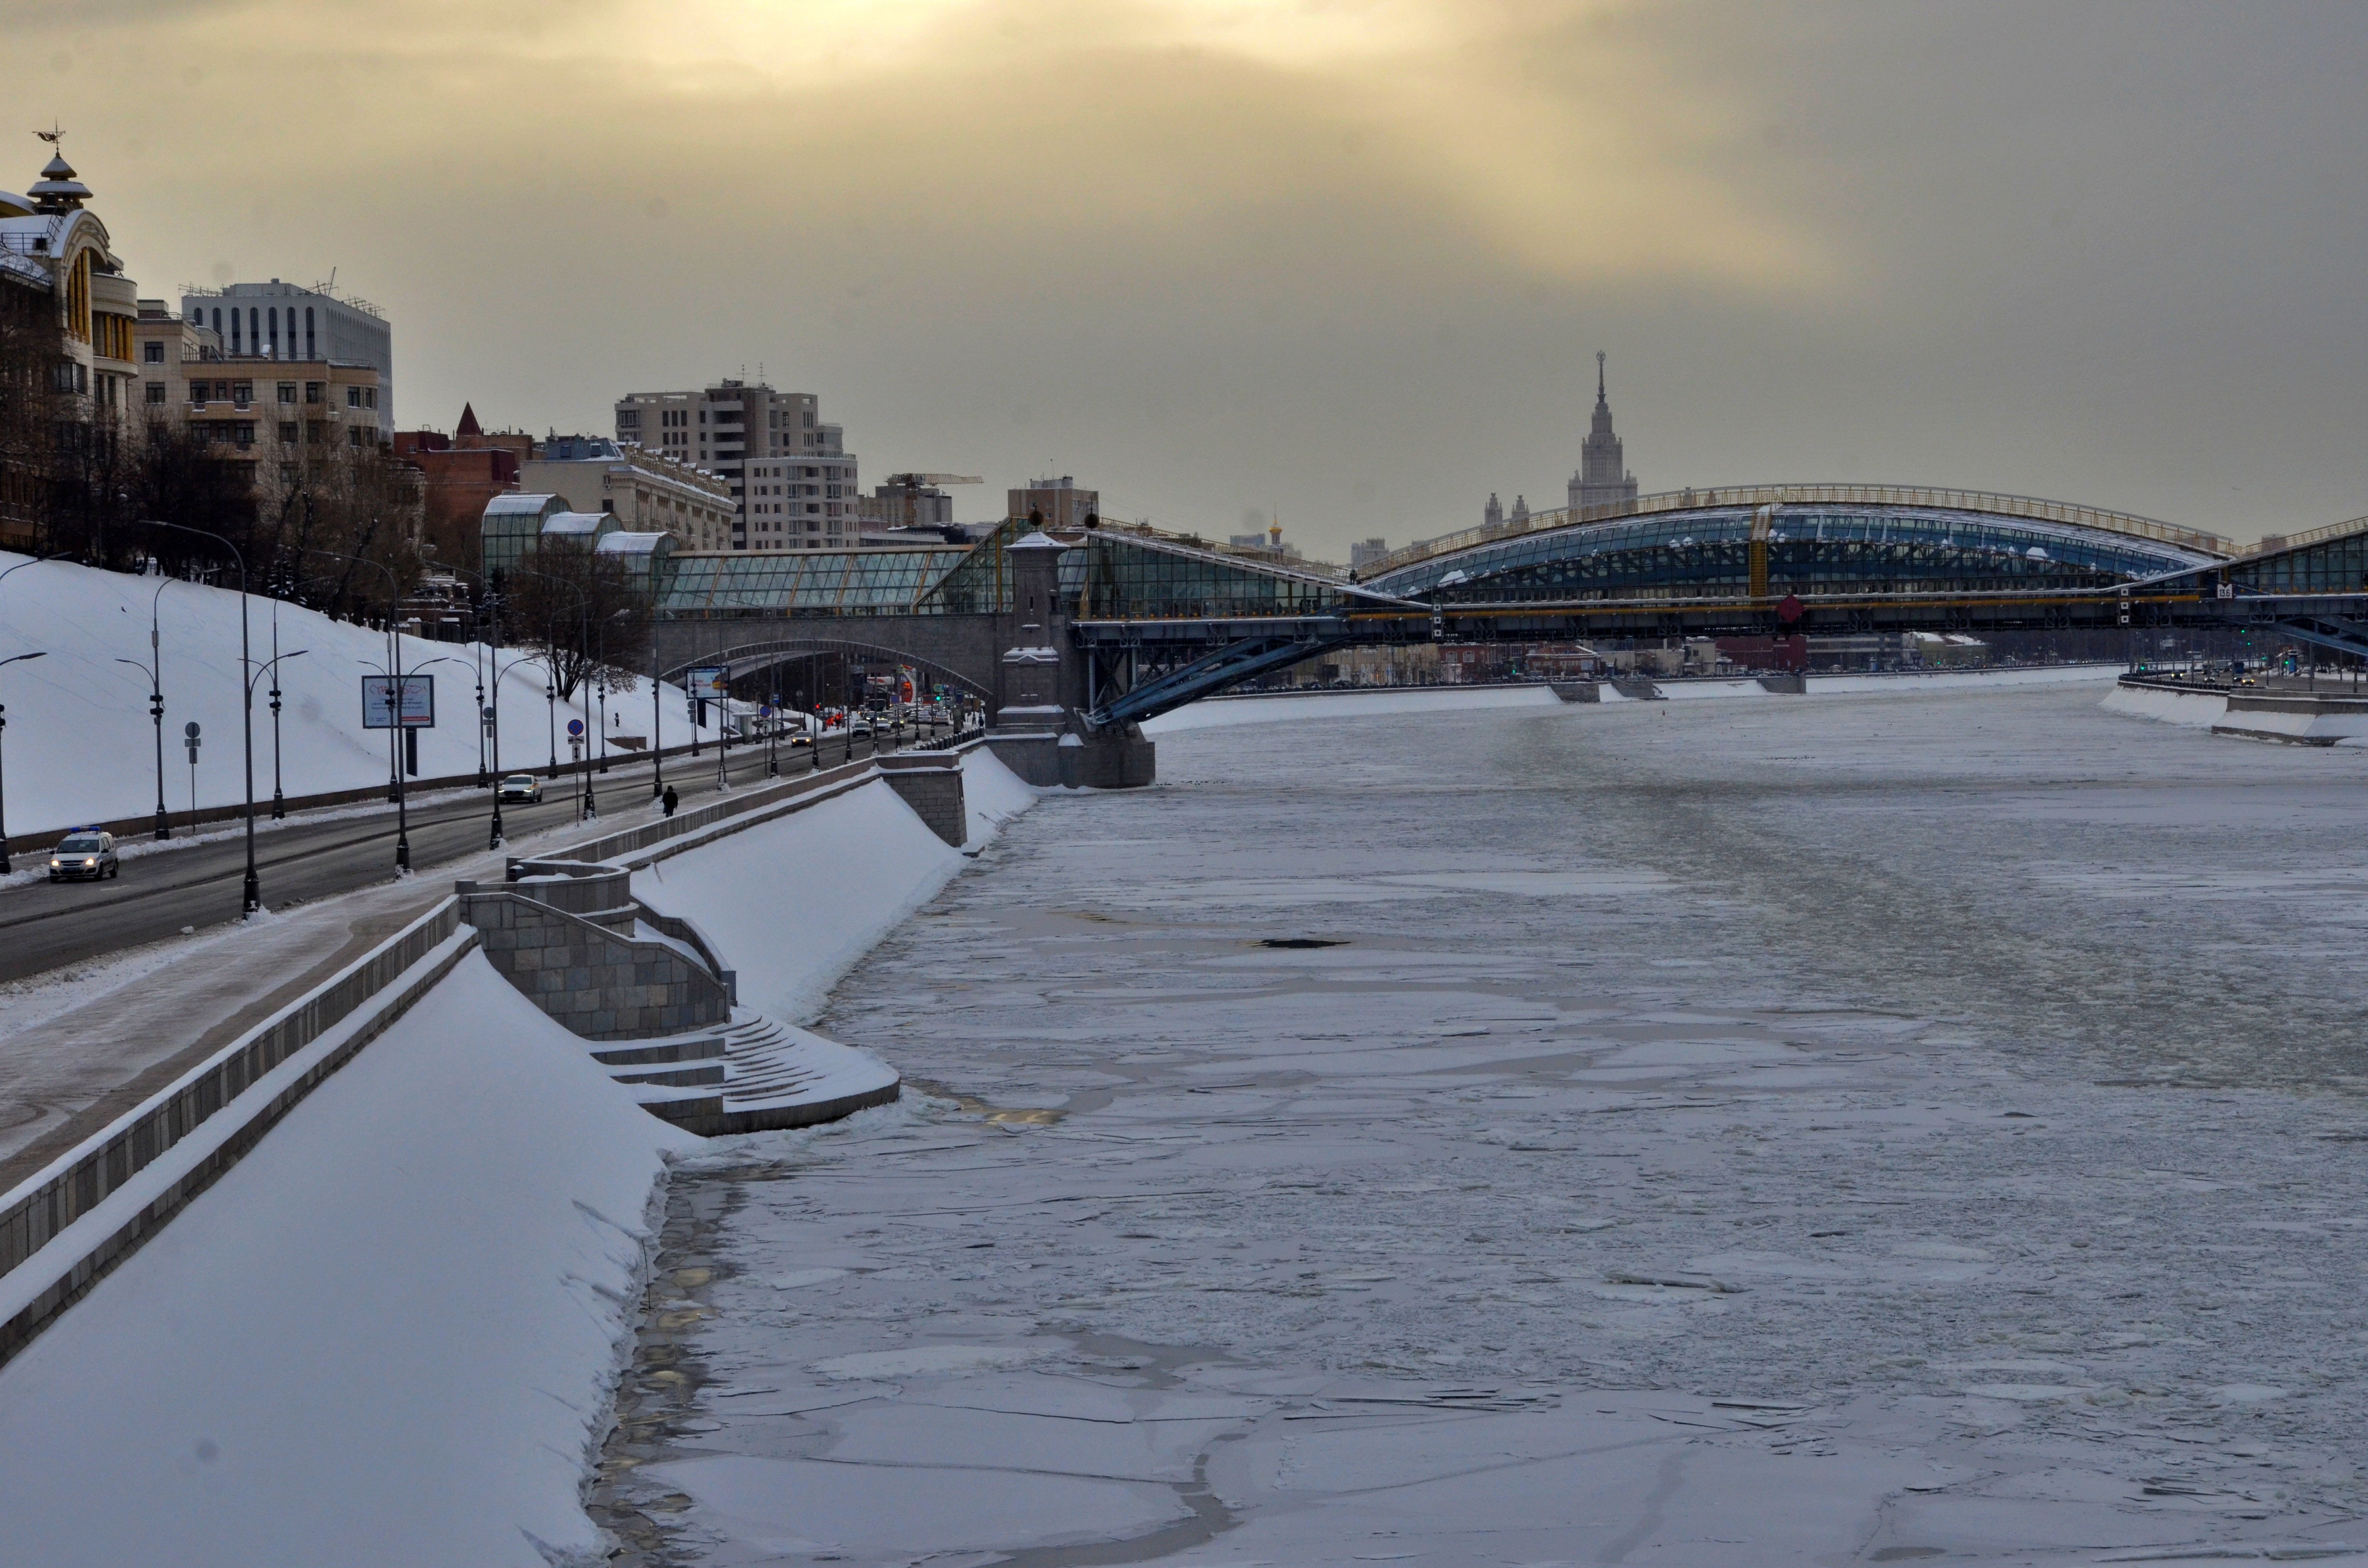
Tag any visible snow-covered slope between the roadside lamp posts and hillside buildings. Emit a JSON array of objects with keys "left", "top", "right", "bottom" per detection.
[{"left": 0, "top": 552, "right": 715, "bottom": 836}]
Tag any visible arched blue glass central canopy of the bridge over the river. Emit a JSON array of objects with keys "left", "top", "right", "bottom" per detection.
[{"left": 1364, "top": 486, "right": 2235, "bottom": 604}]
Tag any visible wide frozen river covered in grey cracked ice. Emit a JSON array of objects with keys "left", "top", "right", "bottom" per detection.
[{"left": 594, "top": 682, "right": 2368, "bottom": 1568}]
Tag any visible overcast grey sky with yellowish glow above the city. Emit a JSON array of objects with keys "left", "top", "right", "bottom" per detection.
[{"left": 0, "top": 0, "right": 2368, "bottom": 559}]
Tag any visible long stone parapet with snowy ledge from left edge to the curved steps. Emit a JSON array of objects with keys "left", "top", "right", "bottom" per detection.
[{"left": 0, "top": 900, "right": 476, "bottom": 1362}]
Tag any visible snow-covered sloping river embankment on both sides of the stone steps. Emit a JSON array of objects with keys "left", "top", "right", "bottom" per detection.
[{"left": 0, "top": 751, "right": 1035, "bottom": 1568}]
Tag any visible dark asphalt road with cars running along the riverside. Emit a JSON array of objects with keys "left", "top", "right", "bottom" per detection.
[{"left": 0, "top": 736, "right": 912, "bottom": 980}]
